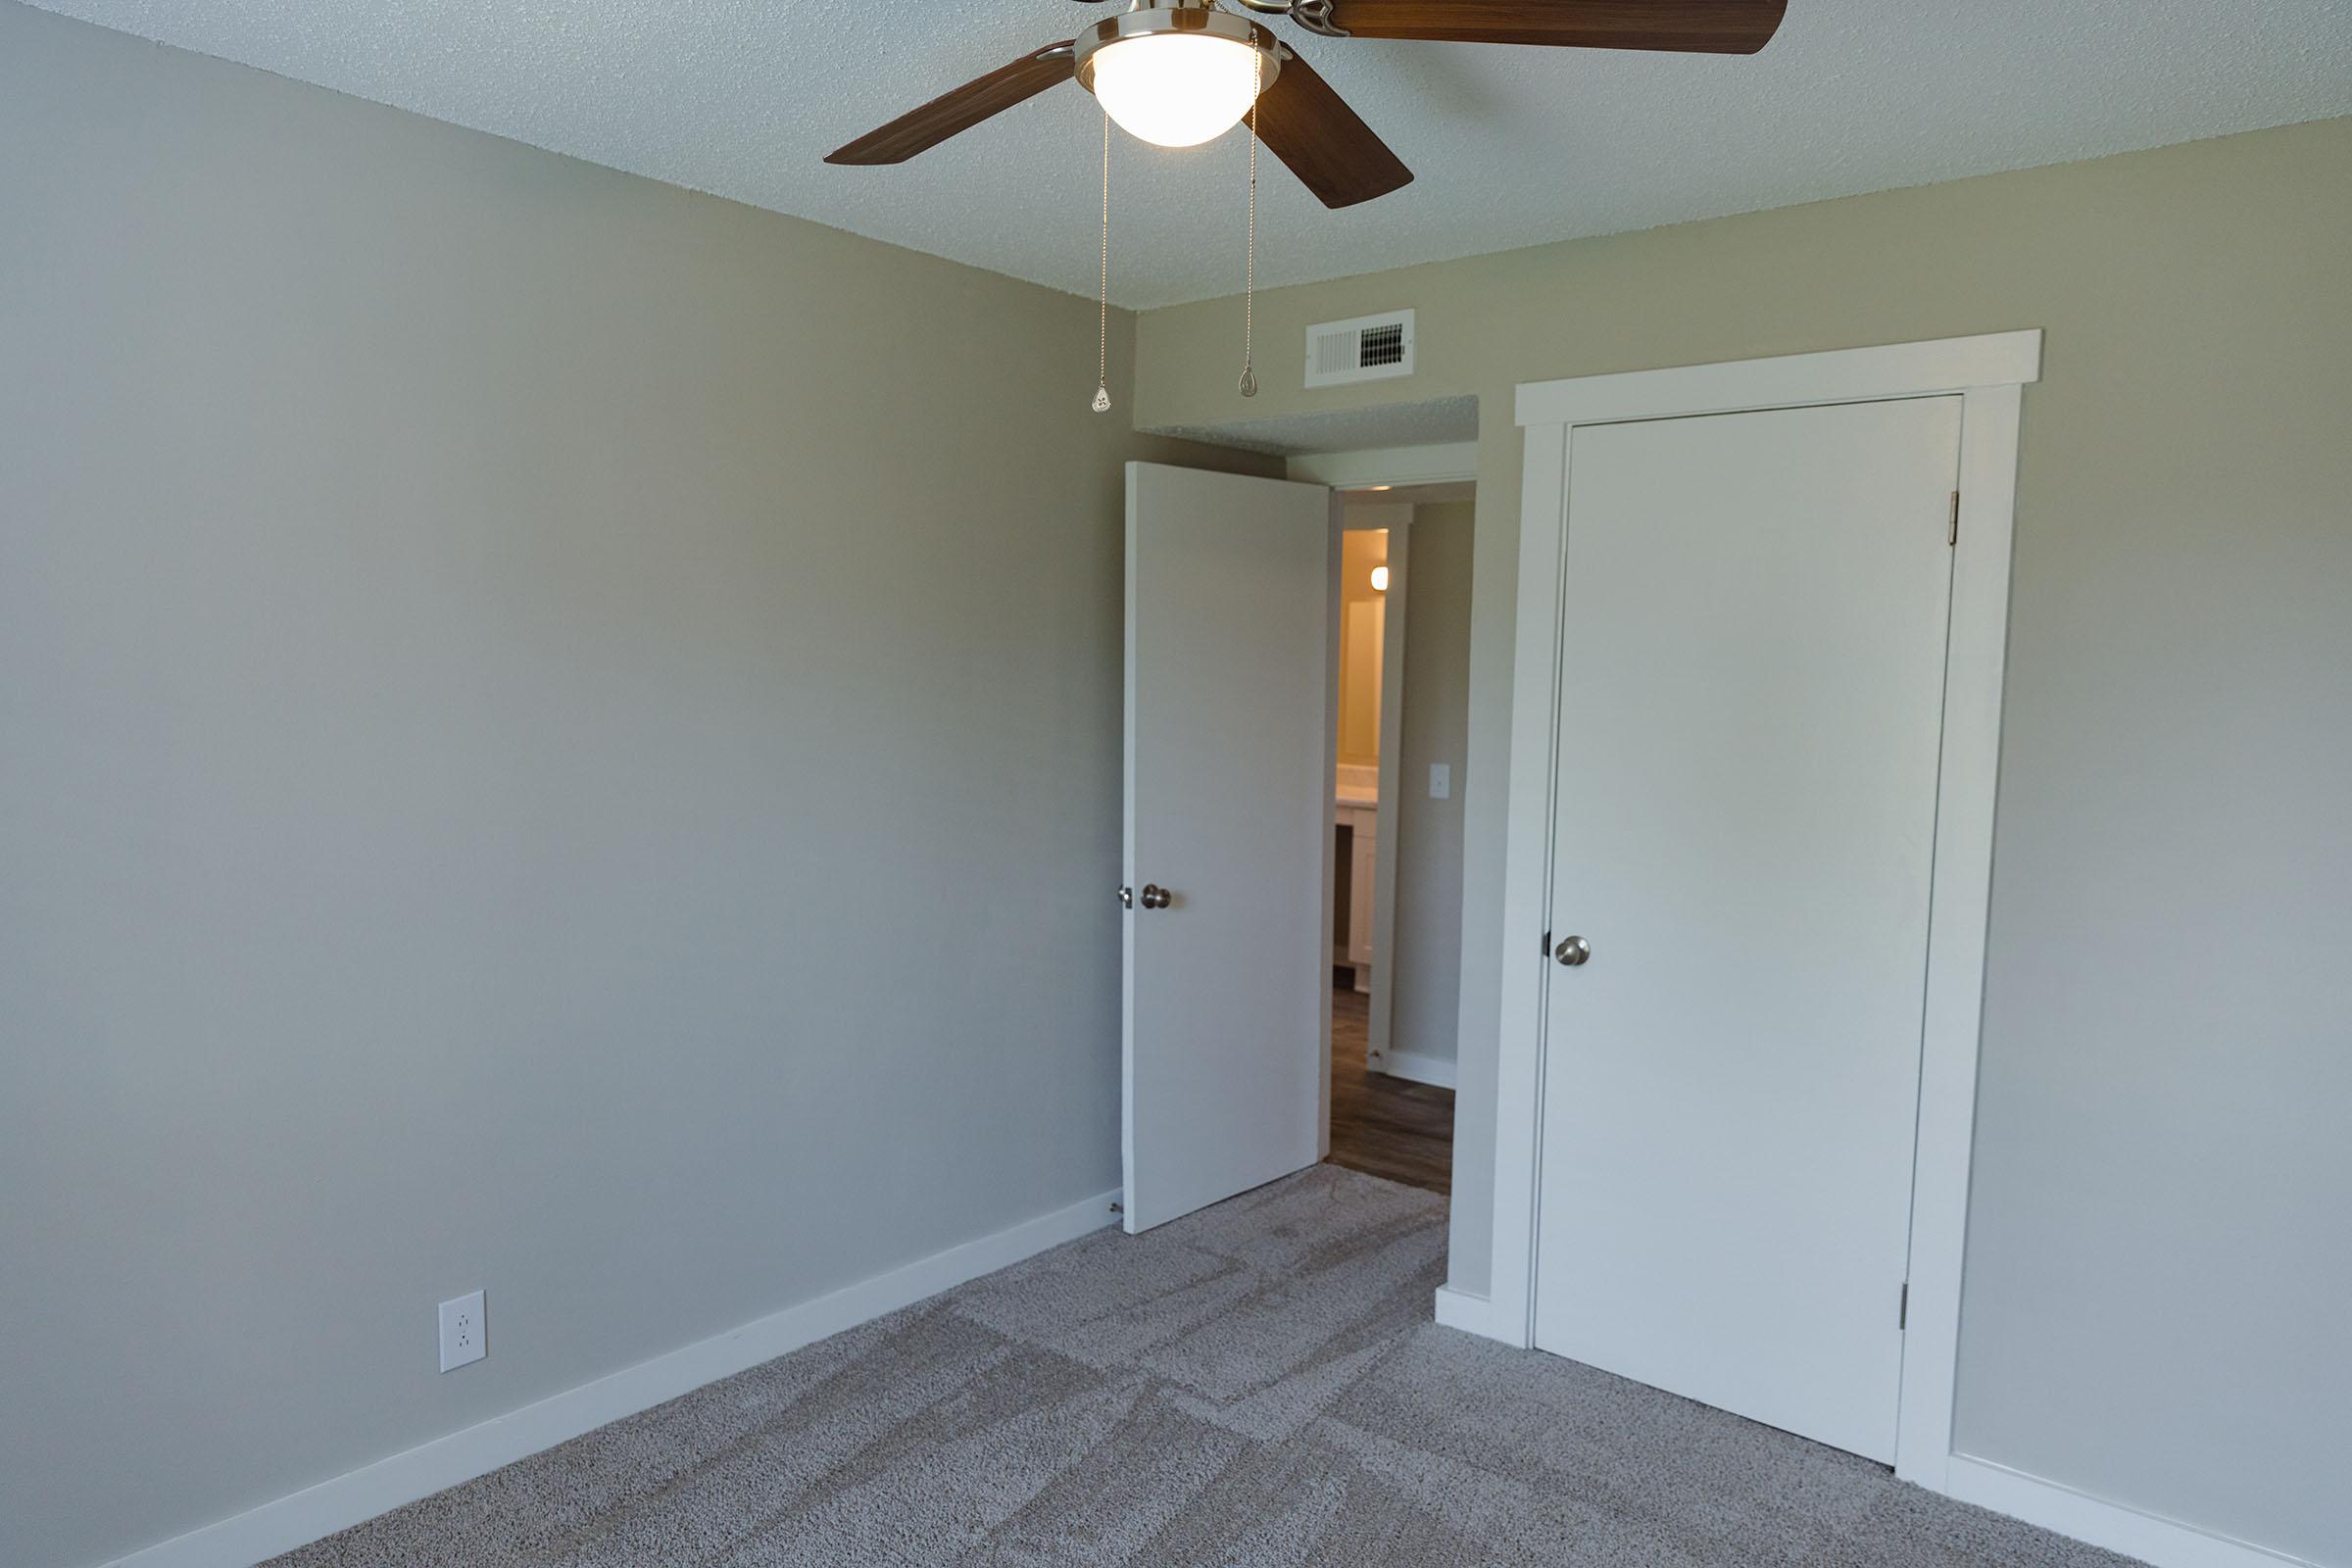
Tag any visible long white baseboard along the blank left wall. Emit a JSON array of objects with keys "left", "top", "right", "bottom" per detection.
[{"left": 96, "top": 1190, "right": 1119, "bottom": 1568}]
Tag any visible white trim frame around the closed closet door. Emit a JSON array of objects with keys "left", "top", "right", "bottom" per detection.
[{"left": 1487, "top": 331, "right": 2041, "bottom": 1491}]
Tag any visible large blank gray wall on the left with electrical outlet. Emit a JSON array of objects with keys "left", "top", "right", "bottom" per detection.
[{"left": 0, "top": 5, "right": 1270, "bottom": 1568}]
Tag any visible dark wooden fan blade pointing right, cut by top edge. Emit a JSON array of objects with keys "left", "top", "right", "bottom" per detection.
[{"left": 1331, "top": 0, "right": 1788, "bottom": 54}]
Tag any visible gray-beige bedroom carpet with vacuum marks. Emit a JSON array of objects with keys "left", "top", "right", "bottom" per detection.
[{"left": 277, "top": 1166, "right": 2124, "bottom": 1568}]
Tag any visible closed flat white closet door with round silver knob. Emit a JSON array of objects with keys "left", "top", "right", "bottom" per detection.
[{"left": 1536, "top": 397, "right": 1959, "bottom": 1460}]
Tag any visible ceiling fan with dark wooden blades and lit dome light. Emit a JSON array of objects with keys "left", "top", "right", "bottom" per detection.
[{"left": 825, "top": 0, "right": 1788, "bottom": 207}]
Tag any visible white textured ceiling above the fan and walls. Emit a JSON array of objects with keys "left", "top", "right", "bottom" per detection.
[{"left": 27, "top": 0, "right": 2352, "bottom": 306}]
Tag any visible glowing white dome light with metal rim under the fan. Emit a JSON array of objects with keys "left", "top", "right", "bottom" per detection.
[{"left": 1077, "top": 5, "right": 1282, "bottom": 148}]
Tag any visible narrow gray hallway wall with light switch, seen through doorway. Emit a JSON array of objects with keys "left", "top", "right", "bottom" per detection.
[{"left": 1383, "top": 501, "right": 1472, "bottom": 1081}]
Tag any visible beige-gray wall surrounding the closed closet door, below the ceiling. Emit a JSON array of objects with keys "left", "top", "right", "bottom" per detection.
[{"left": 1136, "top": 120, "right": 2352, "bottom": 1563}]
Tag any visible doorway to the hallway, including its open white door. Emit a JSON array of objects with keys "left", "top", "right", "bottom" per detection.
[{"left": 1117, "top": 400, "right": 1475, "bottom": 1232}]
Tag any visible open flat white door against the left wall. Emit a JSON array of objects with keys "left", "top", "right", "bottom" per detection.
[{"left": 1122, "top": 464, "right": 1336, "bottom": 1232}]
